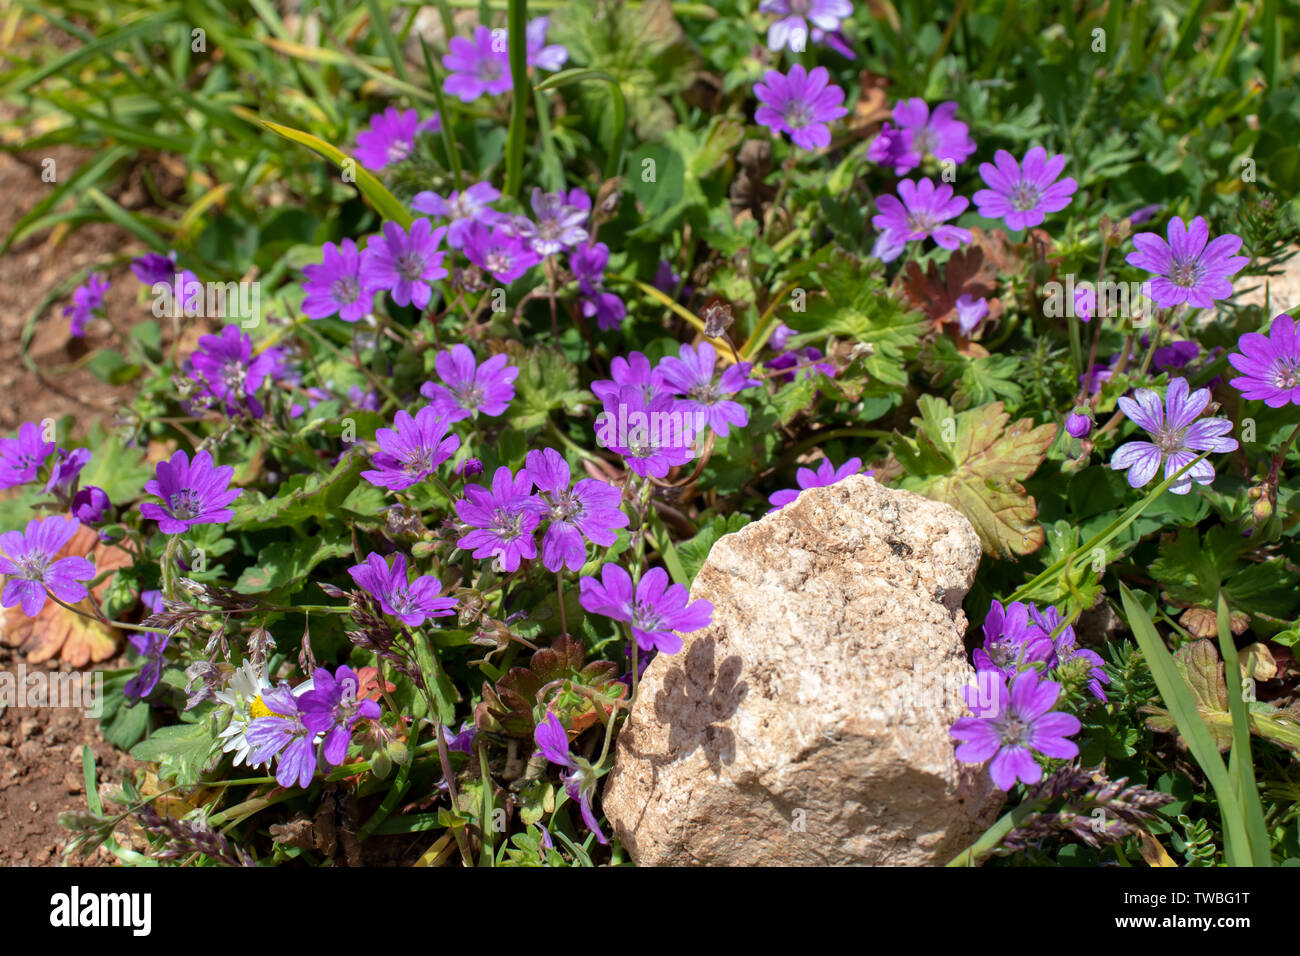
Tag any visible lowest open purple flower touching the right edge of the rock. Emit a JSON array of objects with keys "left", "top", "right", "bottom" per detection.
[{"left": 949, "top": 670, "right": 1082, "bottom": 790}]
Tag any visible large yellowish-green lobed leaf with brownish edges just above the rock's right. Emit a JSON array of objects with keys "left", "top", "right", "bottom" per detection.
[{"left": 894, "top": 395, "right": 1056, "bottom": 557}]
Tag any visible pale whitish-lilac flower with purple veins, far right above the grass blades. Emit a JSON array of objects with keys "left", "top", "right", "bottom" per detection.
[{"left": 1110, "top": 378, "right": 1236, "bottom": 494}]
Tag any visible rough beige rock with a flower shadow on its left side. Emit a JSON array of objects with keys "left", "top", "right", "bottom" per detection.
[{"left": 603, "top": 476, "right": 1001, "bottom": 866}]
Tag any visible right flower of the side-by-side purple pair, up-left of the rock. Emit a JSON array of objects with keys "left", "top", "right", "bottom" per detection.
[{"left": 525, "top": 449, "right": 628, "bottom": 571}]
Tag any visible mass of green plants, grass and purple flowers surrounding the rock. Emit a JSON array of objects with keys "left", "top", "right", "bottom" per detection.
[{"left": 0, "top": 0, "right": 1300, "bottom": 866}]
